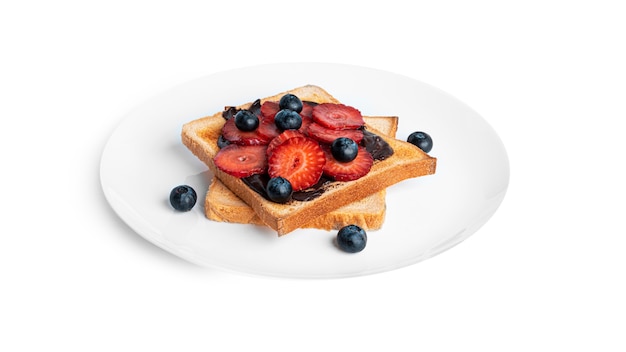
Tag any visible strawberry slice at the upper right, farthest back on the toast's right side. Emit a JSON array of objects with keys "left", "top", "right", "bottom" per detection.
[{"left": 313, "top": 103, "right": 365, "bottom": 130}]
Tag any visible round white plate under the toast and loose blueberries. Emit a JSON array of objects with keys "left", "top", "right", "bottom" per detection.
[{"left": 100, "top": 63, "right": 509, "bottom": 278}]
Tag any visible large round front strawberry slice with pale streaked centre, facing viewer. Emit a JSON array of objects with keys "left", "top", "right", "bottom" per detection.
[{"left": 268, "top": 137, "right": 326, "bottom": 191}]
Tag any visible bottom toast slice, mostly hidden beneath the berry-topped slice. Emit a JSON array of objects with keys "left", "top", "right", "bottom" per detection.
[{"left": 204, "top": 116, "right": 398, "bottom": 230}]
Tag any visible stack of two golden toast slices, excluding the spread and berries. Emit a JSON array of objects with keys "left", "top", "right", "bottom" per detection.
[{"left": 182, "top": 85, "right": 436, "bottom": 236}]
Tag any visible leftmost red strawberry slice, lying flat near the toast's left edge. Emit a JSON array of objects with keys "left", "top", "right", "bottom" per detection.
[{"left": 213, "top": 144, "right": 267, "bottom": 177}]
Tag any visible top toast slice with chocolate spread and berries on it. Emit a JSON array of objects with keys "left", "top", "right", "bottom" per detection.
[{"left": 181, "top": 85, "right": 436, "bottom": 236}]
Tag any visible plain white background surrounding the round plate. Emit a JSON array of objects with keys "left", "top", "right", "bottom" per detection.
[{"left": 0, "top": 0, "right": 626, "bottom": 351}]
